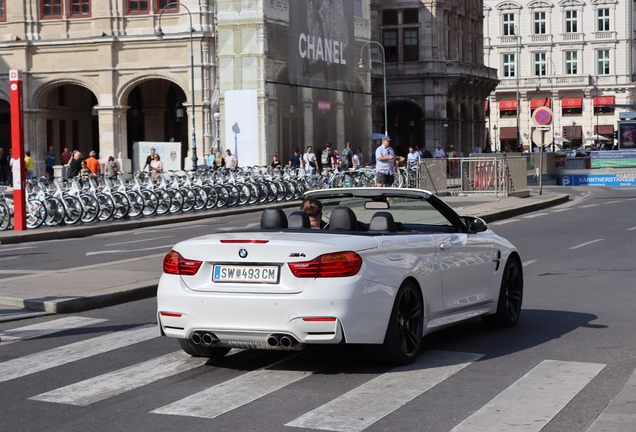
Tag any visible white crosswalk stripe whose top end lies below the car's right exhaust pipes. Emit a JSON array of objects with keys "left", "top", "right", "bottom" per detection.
[{"left": 150, "top": 360, "right": 311, "bottom": 418}]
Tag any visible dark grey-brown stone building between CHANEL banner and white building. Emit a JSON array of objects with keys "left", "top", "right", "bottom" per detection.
[{"left": 371, "top": 0, "right": 497, "bottom": 155}]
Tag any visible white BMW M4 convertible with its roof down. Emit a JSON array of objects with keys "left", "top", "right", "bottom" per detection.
[{"left": 157, "top": 188, "right": 523, "bottom": 364}]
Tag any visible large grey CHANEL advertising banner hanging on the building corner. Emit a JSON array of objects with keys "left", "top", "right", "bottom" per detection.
[{"left": 288, "top": 0, "right": 357, "bottom": 91}]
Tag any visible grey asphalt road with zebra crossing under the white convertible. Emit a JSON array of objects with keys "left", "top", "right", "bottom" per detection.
[{"left": 0, "top": 187, "right": 636, "bottom": 432}]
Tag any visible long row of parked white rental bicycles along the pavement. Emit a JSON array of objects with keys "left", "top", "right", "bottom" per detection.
[{"left": 0, "top": 169, "right": 305, "bottom": 230}]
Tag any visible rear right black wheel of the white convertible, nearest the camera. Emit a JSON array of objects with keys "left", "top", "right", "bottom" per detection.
[{"left": 382, "top": 281, "right": 424, "bottom": 365}]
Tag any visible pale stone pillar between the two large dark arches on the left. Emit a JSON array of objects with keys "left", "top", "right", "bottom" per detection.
[{"left": 95, "top": 105, "right": 132, "bottom": 172}]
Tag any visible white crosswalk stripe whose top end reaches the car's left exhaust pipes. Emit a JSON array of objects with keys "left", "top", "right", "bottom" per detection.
[{"left": 29, "top": 351, "right": 208, "bottom": 406}]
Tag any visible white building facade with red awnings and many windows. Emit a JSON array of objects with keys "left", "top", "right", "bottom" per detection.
[{"left": 483, "top": 0, "right": 636, "bottom": 151}]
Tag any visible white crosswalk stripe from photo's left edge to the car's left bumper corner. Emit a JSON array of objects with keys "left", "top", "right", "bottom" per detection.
[{"left": 0, "top": 324, "right": 159, "bottom": 382}]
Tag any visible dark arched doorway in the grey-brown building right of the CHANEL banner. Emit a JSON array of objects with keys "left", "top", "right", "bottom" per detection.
[{"left": 380, "top": 101, "right": 425, "bottom": 156}]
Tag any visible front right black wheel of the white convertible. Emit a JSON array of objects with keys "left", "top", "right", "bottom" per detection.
[{"left": 481, "top": 258, "right": 523, "bottom": 328}]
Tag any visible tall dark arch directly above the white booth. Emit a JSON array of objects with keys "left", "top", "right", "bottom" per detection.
[{"left": 125, "top": 78, "right": 191, "bottom": 168}]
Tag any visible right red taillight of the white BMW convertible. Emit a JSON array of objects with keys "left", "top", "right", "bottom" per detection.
[{"left": 287, "top": 252, "right": 362, "bottom": 278}]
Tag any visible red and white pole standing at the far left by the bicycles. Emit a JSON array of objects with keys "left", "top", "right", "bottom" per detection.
[{"left": 9, "top": 70, "right": 27, "bottom": 231}]
